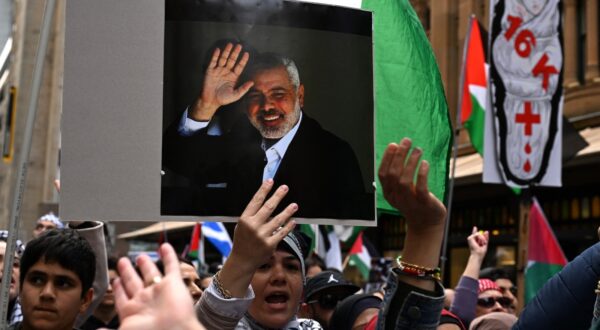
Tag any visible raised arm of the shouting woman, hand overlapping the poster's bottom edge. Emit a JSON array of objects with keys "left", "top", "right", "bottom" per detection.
[{"left": 196, "top": 179, "right": 298, "bottom": 329}]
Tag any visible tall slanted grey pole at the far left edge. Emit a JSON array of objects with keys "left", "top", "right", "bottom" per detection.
[{"left": 0, "top": 0, "right": 56, "bottom": 329}]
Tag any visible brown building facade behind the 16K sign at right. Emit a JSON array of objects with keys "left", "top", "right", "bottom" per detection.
[{"left": 369, "top": 0, "right": 600, "bottom": 285}]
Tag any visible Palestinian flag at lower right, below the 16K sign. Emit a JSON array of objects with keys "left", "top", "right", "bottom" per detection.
[{"left": 525, "top": 198, "right": 567, "bottom": 303}]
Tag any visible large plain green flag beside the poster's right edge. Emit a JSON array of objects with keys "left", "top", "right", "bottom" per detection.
[{"left": 362, "top": 0, "right": 452, "bottom": 212}]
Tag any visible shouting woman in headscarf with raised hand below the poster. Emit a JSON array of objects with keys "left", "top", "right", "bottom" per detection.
[{"left": 196, "top": 179, "right": 322, "bottom": 330}]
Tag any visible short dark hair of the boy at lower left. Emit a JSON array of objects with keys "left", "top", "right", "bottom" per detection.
[{"left": 20, "top": 229, "right": 96, "bottom": 298}]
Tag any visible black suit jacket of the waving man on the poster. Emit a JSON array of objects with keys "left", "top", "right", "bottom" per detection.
[{"left": 162, "top": 114, "right": 374, "bottom": 219}]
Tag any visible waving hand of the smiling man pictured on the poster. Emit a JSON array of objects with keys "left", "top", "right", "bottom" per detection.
[{"left": 188, "top": 43, "right": 254, "bottom": 121}]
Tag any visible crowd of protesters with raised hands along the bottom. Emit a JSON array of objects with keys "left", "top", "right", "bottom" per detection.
[{"left": 0, "top": 139, "right": 600, "bottom": 329}]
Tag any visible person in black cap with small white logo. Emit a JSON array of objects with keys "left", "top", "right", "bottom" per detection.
[{"left": 300, "top": 271, "right": 360, "bottom": 329}]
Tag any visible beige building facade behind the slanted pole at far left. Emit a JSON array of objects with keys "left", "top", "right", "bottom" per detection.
[{"left": 0, "top": 0, "right": 65, "bottom": 239}]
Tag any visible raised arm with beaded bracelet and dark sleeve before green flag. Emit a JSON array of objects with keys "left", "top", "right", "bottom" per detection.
[{"left": 377, "top": 138, "right": 446, "bottom": 329}]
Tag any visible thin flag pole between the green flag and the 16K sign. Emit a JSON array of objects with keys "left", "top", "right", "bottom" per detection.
[{"left": 440, "top": 15, "right": 475, "bottom": 276}]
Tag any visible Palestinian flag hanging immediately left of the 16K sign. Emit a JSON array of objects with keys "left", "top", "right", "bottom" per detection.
[{"left": 460, "top": 17, "right": 487, "bottom": 155}]
